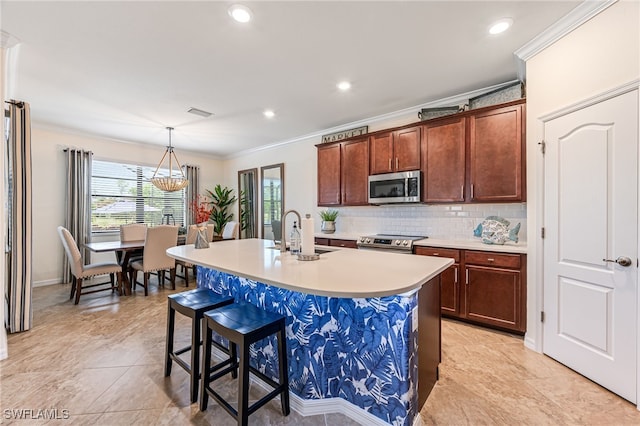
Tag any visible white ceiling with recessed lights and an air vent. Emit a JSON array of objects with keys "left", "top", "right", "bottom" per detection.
[{"left": 0, "top": 0, "right": 580, "bottom": 157}]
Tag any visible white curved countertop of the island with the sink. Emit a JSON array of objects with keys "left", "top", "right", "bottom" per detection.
[{"left": 167, "top": 238, "right": 453, "bottom": 298}]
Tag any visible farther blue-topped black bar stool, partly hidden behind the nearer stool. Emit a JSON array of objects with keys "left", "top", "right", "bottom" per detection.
[{"left": 164, "top": 288, "right": 233, "bottom": 403}]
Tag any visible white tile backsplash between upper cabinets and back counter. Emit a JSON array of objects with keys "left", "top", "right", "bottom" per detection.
[{"left": 316, "top": 203, "right": 527, "bottom": 241}]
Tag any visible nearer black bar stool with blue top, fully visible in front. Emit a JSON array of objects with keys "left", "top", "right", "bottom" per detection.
[{"left": 200, "top": 302, "right": 290, "bottom": 426}]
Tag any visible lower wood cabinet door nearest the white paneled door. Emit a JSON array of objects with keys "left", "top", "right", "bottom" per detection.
[{"left": 464, "top": 265, "right": 524, "bottom": 332}]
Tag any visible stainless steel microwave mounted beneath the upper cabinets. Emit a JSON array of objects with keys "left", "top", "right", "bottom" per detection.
[{"left": 369, "top": 170, "right": 421, "bottom": 204}]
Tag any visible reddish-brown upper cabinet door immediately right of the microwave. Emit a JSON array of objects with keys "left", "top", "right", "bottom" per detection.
[{"left": 422, "top": 117, "right": 466, "bottom": 203}]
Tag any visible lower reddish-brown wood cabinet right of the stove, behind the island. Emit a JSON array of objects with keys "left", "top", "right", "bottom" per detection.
[{"left": 415, "top": 246, "right": 527, "bottom": 333}]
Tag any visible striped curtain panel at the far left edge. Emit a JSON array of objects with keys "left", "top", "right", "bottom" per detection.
[{"left": 5, "top": 101, "right": 33, "bottom": 333}]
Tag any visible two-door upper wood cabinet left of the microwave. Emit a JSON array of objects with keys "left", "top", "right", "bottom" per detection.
[{"left": 318, "top": 138, "right": 369, "bottom": 206}]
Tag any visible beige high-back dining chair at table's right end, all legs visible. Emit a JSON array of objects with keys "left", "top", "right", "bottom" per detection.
[{"left": 129, "top": 225, "right": 178, "bottom": 296}]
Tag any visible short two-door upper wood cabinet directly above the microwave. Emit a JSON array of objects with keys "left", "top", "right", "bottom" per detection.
[{"left": 369, "top": 126, "right": 422, "bottom": 175}]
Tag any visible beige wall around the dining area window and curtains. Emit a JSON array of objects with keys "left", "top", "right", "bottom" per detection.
[{"left": 31, "top": 127, "right": 224, "bottom": 285}]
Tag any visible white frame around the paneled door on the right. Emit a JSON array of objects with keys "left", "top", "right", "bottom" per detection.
[{"left": 536, "top": 79, "right": 640, "bottom": 410}]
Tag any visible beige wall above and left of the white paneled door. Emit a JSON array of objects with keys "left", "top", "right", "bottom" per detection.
[{"left": 526, "top": 1, "right": 640, "bottom": 350}]
